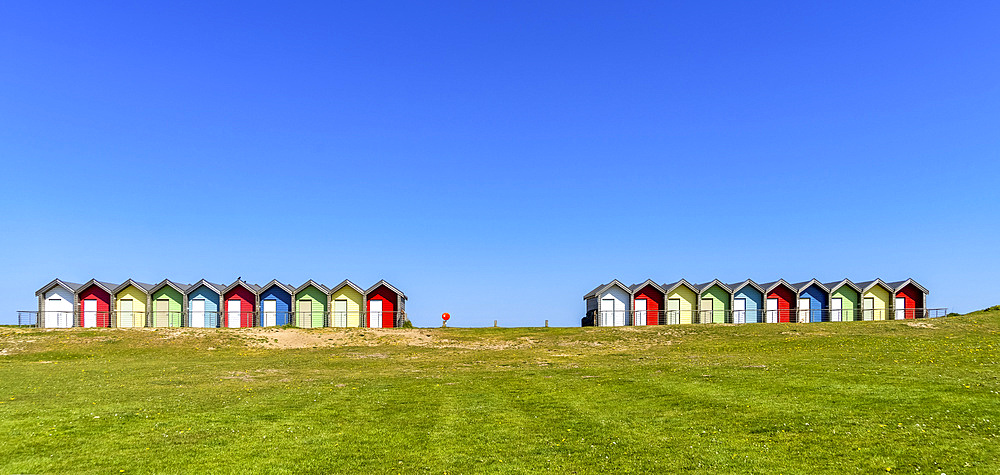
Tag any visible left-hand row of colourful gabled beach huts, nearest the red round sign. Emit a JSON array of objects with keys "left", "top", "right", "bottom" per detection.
[{"left": 35, "top": 279, "right": 406, "bottom": 328}]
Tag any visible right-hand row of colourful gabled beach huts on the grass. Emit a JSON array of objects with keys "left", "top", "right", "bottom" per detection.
[{"left": 582, "top": 279, "right": 947, "bottom": 326}]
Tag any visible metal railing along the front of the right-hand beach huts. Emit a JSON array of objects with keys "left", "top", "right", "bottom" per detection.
[{"left": 584, "top": 308, "right": 948, "bottom": 326}]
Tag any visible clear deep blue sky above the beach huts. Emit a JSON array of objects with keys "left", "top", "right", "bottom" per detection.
[{"left": 0, "top": 1, "right": 1000, "bottom": 326}]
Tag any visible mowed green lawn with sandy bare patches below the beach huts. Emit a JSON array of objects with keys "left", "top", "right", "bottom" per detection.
[{"left": 0, "top": 311, "right": 1000, "bottom": 474}]
